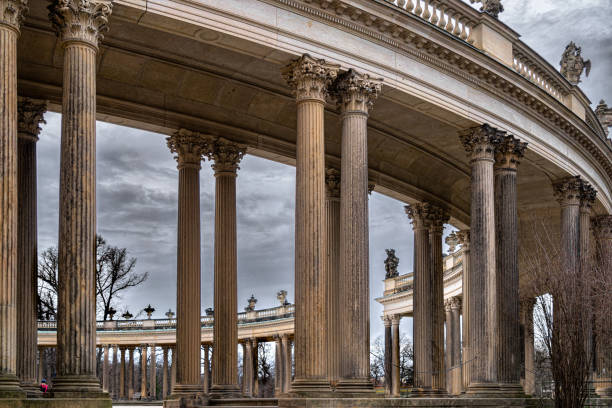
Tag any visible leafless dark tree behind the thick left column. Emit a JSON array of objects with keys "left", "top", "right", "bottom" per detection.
[{"left": 38, "top": 235, "right": 149, "bottom": 320}]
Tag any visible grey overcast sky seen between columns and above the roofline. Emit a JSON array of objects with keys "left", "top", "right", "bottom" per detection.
[{"left": 38, "top": 0, "right": 612, "bottom": 341}]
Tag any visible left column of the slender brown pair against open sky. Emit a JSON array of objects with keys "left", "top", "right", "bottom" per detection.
[{"left": 167, "top": 129, "right": 208, "bottom": 398}]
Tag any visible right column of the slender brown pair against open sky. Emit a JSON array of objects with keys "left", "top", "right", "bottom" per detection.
[{"left": 207, "top": 138, "right": 246, "bottom": 398}]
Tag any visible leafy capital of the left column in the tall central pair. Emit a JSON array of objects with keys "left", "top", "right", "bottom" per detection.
[{"left": 282, "top": 54, "right": 340, "bottom": 102}]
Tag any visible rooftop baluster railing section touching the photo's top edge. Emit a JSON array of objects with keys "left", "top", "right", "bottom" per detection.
[{"left": 384, "top": 0, "right": 480, "bottom": 44}]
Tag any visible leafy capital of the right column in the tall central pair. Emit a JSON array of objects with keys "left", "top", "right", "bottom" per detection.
[{"left": 333, "top": 68, "right": 382, "bottom": 113}]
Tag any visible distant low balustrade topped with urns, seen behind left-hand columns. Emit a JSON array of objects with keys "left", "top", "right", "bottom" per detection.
[{"left": 38, "top": 304, "right": 295, "bottom": 331}]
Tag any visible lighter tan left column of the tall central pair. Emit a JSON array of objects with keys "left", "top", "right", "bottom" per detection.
[{"left": 283, "top": 55, "right": 339, "bottom": 395}]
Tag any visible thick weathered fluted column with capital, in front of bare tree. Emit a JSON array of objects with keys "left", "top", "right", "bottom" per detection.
[{"left": 49, "top": 0, "right": 112, "bottom": 397}]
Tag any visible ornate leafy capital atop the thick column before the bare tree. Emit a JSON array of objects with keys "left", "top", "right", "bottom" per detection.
[{"left": 48, "top": 0, "right": 113, "bottom": 47}]
